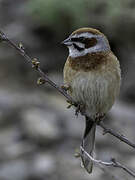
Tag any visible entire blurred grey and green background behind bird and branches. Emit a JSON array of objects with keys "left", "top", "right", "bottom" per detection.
[{"left": 0, "top": 0, "right": 135, "bottom": 180}]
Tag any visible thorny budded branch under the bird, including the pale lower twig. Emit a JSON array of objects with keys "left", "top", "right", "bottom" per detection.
[{"left": 0, "top": 30, "right": 135, "bottom": 178}]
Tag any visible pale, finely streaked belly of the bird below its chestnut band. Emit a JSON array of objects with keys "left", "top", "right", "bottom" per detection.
[{"left": 70, "top": 72, "right": 119, "bottom": 117}]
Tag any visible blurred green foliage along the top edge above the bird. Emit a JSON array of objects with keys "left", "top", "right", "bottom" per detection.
[{"left": 28, "top": 0, "right": 135, "bottom": 34}]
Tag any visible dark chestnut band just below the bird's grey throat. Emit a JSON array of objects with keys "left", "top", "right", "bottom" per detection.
[{"left": 68, "top": 51, "right": 109, "bottom": 71}]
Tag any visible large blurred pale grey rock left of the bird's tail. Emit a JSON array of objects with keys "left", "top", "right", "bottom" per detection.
[{"left": 22, "top": 108, "right": 61, "bottom": 143}]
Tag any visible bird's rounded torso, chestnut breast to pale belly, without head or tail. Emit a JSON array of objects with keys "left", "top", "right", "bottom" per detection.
[{"left": 64, "top": 51, "right": 120, "bottom": 116}]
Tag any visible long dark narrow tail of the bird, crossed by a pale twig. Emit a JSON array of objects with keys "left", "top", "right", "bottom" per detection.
[{"left": 81, "top": 117, "right": 96, "bottom": 173}]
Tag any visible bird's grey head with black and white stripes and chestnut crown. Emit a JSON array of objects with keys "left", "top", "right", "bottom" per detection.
[{"left": 62, "top": 28, "right": 110, "bottom": 57}]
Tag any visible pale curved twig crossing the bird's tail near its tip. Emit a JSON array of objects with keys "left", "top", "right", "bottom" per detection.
[{"left": 80, "top": 146, "right": 135, "bottom": 178}]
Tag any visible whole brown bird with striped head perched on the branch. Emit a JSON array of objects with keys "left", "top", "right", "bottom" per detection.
[{"left": 63, "top": 28, "right": 121, "bottom": 173}]
